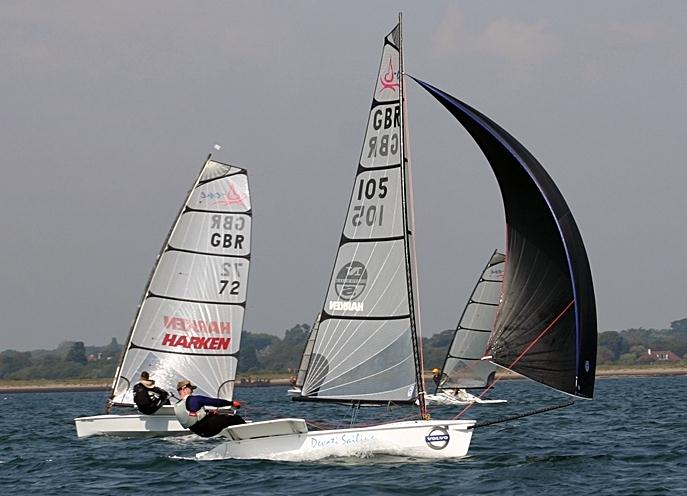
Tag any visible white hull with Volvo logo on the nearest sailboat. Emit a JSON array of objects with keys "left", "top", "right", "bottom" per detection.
[{"left": 196, "top": 419, "right": 475, "bottom": 461}]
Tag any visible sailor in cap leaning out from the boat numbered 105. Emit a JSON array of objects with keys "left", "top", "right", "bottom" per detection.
[{"left": 174, "top": 380, "right": 245, "bottom": 437}]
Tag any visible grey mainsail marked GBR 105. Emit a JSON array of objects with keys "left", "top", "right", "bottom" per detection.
[{"left": 294, "top": 23, "right": 420, "bottom": 403}]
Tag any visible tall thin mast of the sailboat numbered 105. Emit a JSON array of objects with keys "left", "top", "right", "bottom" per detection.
[{"left": 398, "top": 12, "right": 428, "bottom": 418}]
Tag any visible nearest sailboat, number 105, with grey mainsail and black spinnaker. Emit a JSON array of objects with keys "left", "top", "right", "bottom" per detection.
[{"left": 196, "top": 13, "right": 597, "bottom": 462}]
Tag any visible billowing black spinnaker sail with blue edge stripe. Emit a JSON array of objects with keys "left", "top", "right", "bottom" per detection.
[{"left": 415, "top": 79, "right": 597, "bottom": 398}]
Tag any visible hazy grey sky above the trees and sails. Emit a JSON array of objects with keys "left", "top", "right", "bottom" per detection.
[{"left": 0, "top": 0, "right": 687, "bottom": 350}]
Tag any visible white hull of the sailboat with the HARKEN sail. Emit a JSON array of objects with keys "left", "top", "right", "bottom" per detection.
[{"left": 74, "top": 407, "right": 190, "bottom": 437}]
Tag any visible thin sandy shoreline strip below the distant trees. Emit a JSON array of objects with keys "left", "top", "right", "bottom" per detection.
[{"left": 0, "top": 367, "right": 687, "bottom": 394}]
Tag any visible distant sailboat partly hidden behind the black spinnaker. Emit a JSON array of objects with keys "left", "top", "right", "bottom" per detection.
[{"left": 427, "top": 251, "right": 506, "bottom": 405}]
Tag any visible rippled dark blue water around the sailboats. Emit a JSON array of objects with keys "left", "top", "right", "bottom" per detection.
[{"left": 0, "top": 376, "right": 687, "bottom": 496}]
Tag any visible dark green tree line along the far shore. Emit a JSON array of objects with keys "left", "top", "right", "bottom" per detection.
[{"left": 0, "top": 318, "right": 687, "bottom": 380}]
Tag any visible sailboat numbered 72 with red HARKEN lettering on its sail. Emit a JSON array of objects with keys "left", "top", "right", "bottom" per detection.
[{"left": 74, "top": 157, "right": 252, "bottom": 437}]
